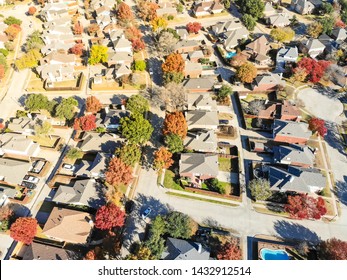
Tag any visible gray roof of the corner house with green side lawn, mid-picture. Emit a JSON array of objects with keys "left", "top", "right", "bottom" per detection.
[{"left": 179, "top": 153, "right": 218, "bottom": 177}]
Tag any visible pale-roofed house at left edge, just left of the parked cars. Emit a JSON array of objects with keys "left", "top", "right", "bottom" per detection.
[{"left": 0, "top": 158, "right": 32, "bottom": 185}]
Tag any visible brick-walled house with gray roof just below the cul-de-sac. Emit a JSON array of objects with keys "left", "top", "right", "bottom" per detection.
[{"left": 273, "top": 120, "right": 312, "bottom": 144}]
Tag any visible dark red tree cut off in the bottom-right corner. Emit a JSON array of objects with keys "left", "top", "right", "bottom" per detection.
[{"left": 317, "top": 238, "right": 347, "bottom": 260}]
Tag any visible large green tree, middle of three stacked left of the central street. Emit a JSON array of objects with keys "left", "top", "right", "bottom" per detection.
[{"left": 120, "top": 114, "right": 153, "bottom": 145}]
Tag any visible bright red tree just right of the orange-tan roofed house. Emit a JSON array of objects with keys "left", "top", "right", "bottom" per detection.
[{"left": 95, "top": 204, "right": 125, "bottom": 230}]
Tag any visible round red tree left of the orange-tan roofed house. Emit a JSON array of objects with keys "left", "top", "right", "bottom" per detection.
[{"left": 10, "top": 217, "right": 38, "bottom": 245}]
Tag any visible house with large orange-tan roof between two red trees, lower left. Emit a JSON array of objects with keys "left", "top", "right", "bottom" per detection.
[{"left": 42, "top": 207, "right": 94, "bottom": 245}]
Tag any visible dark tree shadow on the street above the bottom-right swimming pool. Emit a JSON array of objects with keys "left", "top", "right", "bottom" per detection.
[{"left": 274, "top": 221, "right": 321, "bottom": 245}]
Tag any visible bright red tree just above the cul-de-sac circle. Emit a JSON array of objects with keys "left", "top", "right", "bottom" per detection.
[{"left": 298, "top": 57, "right": 330, "bottom": 83}]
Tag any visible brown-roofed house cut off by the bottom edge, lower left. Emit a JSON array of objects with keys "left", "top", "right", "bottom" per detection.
[{"left": 17, "top": 242, "right": 82, "bottom": 260}]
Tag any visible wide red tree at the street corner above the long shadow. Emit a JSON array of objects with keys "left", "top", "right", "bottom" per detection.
[{"left": 284, "top": 194, "right": 327, "bottom": 220}]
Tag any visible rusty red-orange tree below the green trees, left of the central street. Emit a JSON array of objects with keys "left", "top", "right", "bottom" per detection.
[{"left": 105, "top": 157, "right": 133, "bottom": 187}]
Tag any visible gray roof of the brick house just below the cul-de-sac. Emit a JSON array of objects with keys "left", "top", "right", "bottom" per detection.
[{"left": 273, "top": 120, "right": 312, "bottom": 139}]
